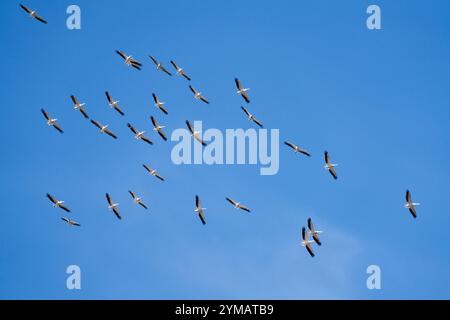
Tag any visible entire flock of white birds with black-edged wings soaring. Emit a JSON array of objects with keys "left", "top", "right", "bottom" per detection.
[{"left": 20, "top": 4, "right": 420, "bottom": 257}]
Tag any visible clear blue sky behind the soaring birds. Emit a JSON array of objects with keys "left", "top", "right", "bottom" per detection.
[{"left": 0, "top": 0, "right": 450, "bottom": 299}]
